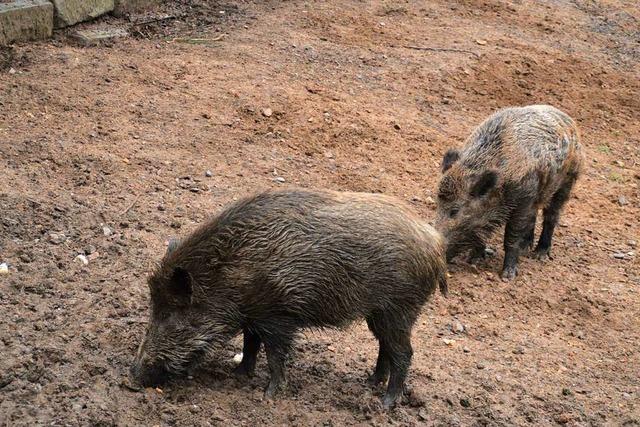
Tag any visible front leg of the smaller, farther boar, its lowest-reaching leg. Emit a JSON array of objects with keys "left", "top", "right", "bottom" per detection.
[{"left": 501, "top": 204, "right": 536, "bottom": 280}]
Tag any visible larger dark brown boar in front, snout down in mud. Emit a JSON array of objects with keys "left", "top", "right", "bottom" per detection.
[{"left": 131, "top": 190, "right": 447, "bottom": 407}]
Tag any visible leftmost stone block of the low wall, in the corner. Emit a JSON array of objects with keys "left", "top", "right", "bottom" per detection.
[{"left": 0, "top": 0, "right": 53, "bottom": 46}]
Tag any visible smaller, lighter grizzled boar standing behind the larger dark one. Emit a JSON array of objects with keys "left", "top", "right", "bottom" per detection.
[{"left": 436, "top": 105, "right": 583, "bottom": 280}]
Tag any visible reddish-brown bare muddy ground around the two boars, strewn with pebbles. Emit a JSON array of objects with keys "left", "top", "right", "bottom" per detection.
[{"left": 0, "top": 0, "right": 640, "bottom": 426}]
